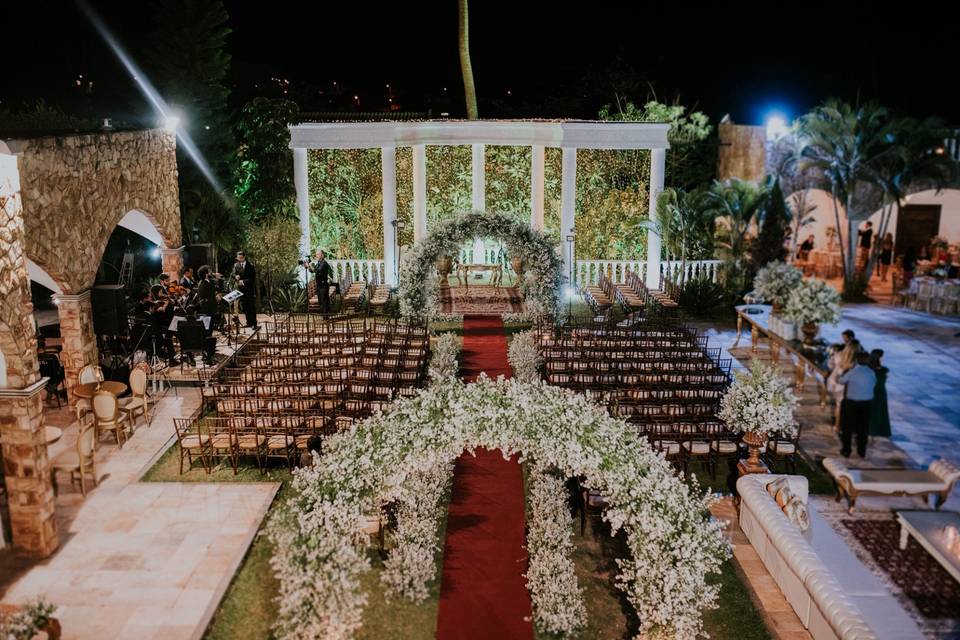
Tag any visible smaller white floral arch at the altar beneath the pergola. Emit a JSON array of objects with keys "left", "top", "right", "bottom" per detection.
[{"left": 399, "top": 211, "right": 563, "bottom": 321}]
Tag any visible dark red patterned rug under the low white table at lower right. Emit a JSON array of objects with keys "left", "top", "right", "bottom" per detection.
[{"left": 816, "top": 499, "right": 960, "bottom": 640}]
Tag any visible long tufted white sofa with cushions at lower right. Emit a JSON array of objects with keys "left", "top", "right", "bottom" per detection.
[{"left": 737, "top": 474, "right": 923, "bottom": 640}]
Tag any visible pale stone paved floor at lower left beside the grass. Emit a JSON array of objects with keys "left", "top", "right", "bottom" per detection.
[{"left": 0, "top": 389, "right": 278, "bottom": 640}]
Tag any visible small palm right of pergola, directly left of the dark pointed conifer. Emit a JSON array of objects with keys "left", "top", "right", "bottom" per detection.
[{"left": 704, "top": 178, "right": 770, "bottom": 289}]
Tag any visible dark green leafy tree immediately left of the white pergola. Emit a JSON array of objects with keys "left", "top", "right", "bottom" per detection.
[{"left": 233, "top": 97, "right": 300, "bottom": 223}]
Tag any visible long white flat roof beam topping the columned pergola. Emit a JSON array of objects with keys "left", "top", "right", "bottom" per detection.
[{"left": 290, "top": 120, "right": 670, "bottom": 149}]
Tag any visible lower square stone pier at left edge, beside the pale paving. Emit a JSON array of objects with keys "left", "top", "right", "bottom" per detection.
[{"left": 0, "top": 378, "right": 60, "bottom": 556}]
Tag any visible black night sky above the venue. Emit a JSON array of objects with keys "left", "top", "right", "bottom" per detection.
[{"left": 0, "top": 0, "right": 960, "bottom": 124}]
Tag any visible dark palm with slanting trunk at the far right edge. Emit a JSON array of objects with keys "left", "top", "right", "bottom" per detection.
[{"left": 867, "top": 118, "right": 960, "bottom": 275}]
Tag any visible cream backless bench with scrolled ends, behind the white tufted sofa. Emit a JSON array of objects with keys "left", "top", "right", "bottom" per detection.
[{"left": 823, "top": 458, "right": 960, "bottom": 513}]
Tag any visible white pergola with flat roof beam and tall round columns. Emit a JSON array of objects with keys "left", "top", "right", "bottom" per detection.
[{"left": 290, "top": 120, "right": 670, "bottom": 288}]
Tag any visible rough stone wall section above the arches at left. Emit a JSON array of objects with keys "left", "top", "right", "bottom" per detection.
[{"left": 10, "top": 129, "right": 181, "bottom": 294}]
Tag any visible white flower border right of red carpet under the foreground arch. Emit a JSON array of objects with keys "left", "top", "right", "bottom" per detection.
[{"left": 525, "top": 468, "right": 587, "bottom": 637}]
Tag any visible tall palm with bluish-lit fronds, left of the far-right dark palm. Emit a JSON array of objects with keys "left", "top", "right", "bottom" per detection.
[{"left": 799, "top": 100, "right": 894, "bottom": 293}]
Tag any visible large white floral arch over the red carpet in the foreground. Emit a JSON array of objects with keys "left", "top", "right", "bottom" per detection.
[{"left": 269, "top": 375, "right": 730, "bottom": 640}]
